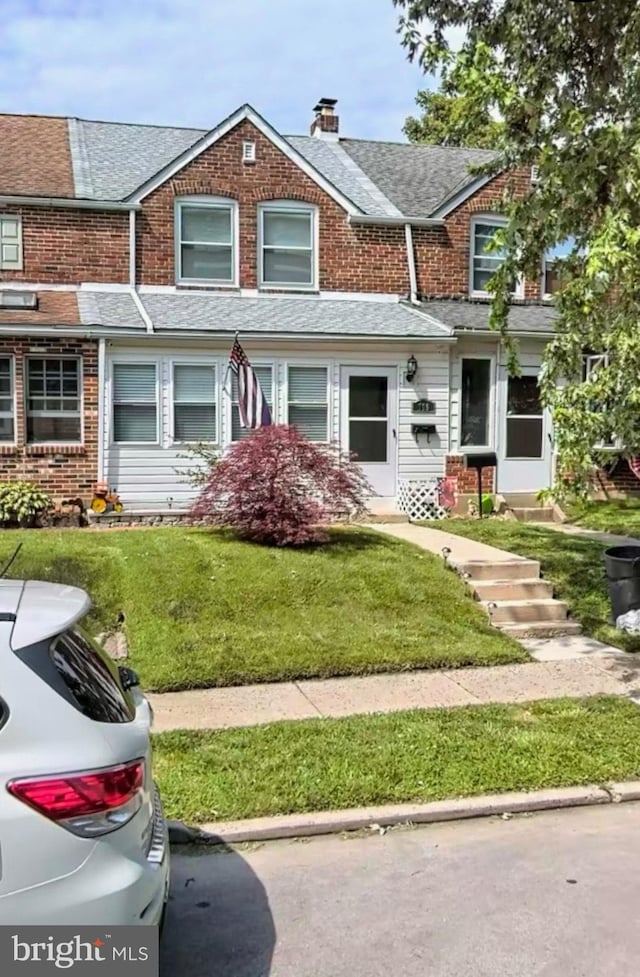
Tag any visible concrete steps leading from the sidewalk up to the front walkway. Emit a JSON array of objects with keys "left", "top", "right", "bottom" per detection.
[{"left": 458, "top": 559, "right": 582, "bottom": 639}]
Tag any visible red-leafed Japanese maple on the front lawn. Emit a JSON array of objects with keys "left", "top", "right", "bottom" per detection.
[{"left": 191, "top": 425, "right": 370, "bottom": 546}]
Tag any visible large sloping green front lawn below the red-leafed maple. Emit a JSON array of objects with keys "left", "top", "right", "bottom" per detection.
[{"left": 0, "top": 529, "right": 528, "bottom": 691}]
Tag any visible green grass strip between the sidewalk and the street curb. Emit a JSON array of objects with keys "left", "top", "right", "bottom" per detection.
[{"left": 154, "top": 698, "right": 640, "bottom": 823}]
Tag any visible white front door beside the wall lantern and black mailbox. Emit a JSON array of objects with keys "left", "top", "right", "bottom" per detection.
[{"left": 340, "top": 366, "right": 397, "bottom": 497}]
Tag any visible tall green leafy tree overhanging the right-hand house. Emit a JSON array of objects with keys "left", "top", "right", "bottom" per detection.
[{"left": 393, "top": 0, "right": 640, "bottom": 492}]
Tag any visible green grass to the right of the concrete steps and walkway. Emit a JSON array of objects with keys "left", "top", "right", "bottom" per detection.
[{"left": 446, "top": 519, "right": 640, "bottom": 651}]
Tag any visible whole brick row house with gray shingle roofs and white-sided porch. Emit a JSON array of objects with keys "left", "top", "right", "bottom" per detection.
[{"left": 0, "top": 99, "right": 588, "bottom": 511}]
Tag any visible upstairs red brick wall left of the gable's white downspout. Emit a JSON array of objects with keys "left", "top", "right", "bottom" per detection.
[{"left": 0, "top": 204, "right": 129, "bottom": 285}]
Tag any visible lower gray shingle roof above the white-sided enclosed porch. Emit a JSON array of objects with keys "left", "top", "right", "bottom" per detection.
[{"left": 78, "top": 292, "right": 450, "bottom": 339}]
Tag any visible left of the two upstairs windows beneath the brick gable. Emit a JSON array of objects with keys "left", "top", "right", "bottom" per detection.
[{"left": 176, "top": 197, "right": 238, "bottom": 286}]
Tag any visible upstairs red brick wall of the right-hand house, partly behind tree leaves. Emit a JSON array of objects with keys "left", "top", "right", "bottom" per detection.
[{"left": 413, "top": 171, "right": 540, "bottom": 299}]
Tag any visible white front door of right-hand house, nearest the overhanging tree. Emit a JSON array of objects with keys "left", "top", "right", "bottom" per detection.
[{"left": 497, "top": 367, "right": 551, "bottom": 494}]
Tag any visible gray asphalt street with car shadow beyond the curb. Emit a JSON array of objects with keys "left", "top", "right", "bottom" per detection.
[{"left": 161, "top": 804, "right": 640, "bottom": 977}]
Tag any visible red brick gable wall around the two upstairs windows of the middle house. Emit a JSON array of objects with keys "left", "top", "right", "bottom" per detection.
[{"left": 137, "top": 122, "right": 409, "bottom": 295}]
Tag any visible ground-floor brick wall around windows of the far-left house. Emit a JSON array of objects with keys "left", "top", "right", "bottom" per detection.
[{"left": 0, "top": 338, "right": 98, "bottom": 502}]
